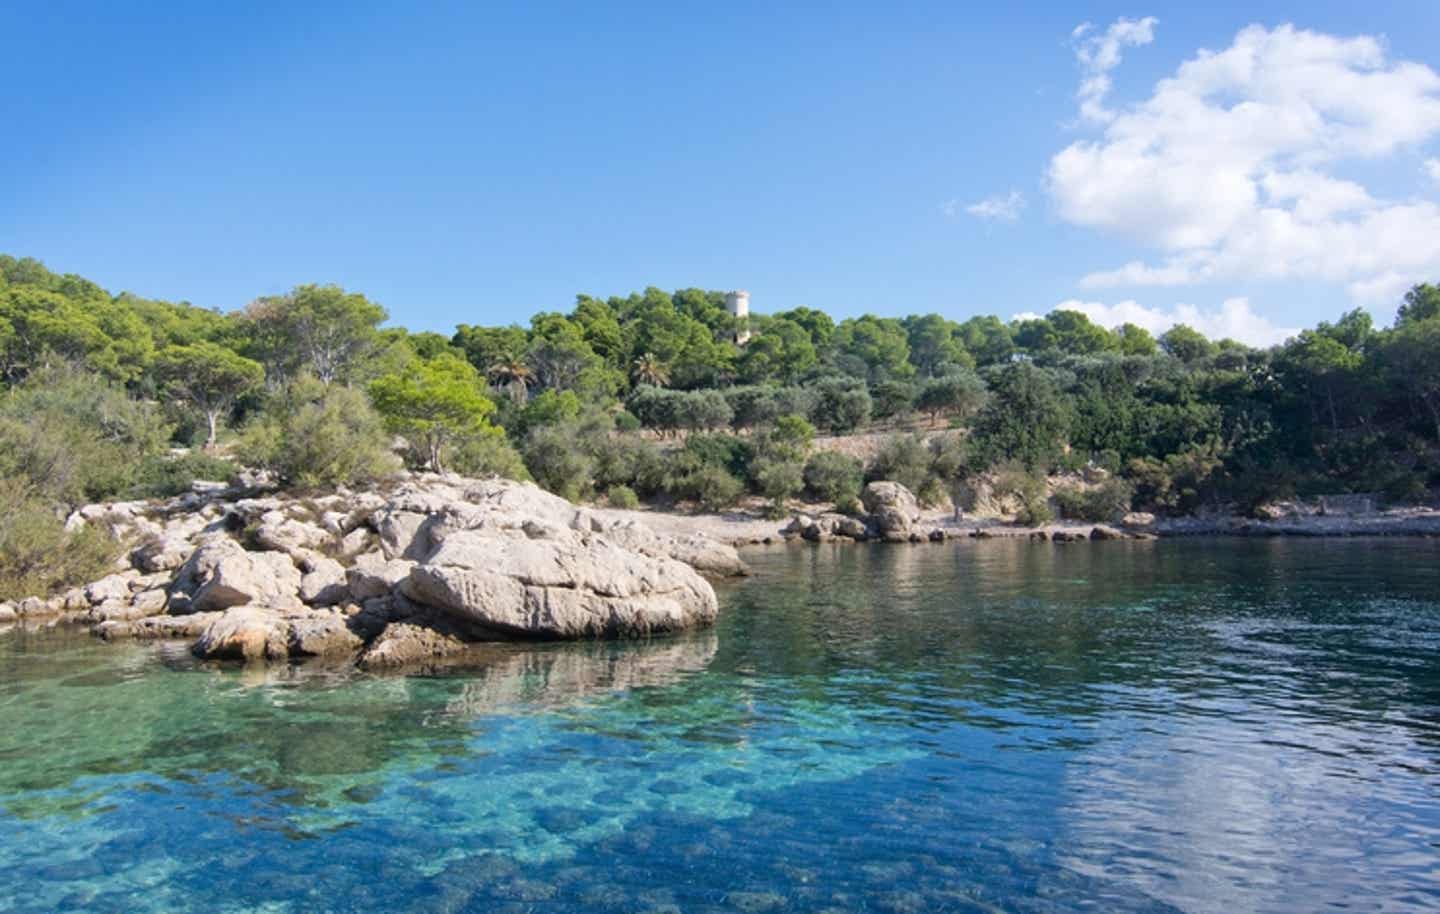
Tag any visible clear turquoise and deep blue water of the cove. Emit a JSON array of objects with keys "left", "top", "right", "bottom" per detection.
[{"left": 0, "top": 540, "right": 1440, "bottom": 914}]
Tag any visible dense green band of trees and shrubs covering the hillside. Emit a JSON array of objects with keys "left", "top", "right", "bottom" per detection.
[{"left": 0, "top": 256, "right": 1440, "bottom": 601}]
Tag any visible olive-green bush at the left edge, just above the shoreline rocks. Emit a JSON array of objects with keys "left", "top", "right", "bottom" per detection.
[{"left": 0, "top": 479, "right": 120, "bottom": 600}]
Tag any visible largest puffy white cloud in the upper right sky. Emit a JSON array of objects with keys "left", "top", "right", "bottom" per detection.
[{"left": 1047, "top": 20, "right": 1440, "bottom": 304}]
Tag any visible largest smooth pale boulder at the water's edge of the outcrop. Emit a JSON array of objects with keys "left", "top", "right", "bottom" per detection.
[{"left": 400, "top": 528, "right": 717, "bottom": 639}]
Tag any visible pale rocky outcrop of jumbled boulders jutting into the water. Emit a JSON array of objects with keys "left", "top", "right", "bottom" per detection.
[{"left": 11, "top": 475, "right": 746, "bottom": 669}]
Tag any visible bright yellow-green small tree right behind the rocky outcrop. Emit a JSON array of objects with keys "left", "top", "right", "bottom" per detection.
[{"left": 370, "top": 356, "right": 495, "bottom": 472}]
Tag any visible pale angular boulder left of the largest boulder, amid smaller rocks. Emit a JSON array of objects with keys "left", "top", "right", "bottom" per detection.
[{"left": 170, "top": 537, "right": 301, "bottom": 613}]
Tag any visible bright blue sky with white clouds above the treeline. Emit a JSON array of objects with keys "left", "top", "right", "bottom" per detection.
[{"left": 0, "top": 0, "right": 1440, "bottom": 341}]
